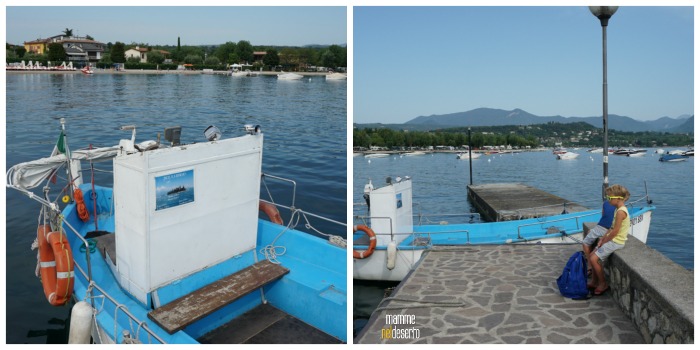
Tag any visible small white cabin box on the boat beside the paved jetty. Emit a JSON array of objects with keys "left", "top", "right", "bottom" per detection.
[{"left": 369, "top": 179, "right": 413, "bottom": 246}]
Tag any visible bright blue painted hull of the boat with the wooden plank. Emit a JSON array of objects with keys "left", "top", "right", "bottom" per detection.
[{"left": 63, "top": 185, "right": 347, "bottom": 344}]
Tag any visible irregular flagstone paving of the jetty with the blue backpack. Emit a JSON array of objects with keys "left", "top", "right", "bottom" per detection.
[{"left": 354, "top": 244, "right": 644, "bottom": 344}]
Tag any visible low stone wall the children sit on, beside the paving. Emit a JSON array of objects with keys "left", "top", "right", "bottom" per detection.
[{"left": 605, "top": 236, "right": 694, "bottom": 344}]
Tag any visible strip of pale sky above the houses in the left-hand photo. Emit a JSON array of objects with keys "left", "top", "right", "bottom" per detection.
[{"left": 6, "top": 6, "right": 347, "bottom": 46}]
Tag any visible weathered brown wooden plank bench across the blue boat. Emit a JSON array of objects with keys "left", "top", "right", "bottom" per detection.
[{"left": 148, "top": 260, "right": 289, "bottom": 334}]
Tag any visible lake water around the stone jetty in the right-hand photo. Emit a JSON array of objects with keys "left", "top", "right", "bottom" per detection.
[{"left": 353, "top": 148, "right": 695, "bottom": 331}]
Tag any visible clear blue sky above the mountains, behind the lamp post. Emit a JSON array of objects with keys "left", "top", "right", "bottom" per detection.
[{"left": 352, "top": 6, "right": 694, "bottom": 123}]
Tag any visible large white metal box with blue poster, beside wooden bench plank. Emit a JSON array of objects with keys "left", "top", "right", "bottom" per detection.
[{"left": 114, "top": 134, "right": 263, "bottom": 303}]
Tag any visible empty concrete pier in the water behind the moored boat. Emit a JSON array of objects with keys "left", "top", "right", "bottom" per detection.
[{"left": 467, "top": 183, "right": 589, "bottom": 221}]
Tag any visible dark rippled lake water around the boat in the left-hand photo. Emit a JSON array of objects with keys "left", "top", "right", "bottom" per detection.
[{"left": 5, "top": 74, "right": 347, "bottom": 343}]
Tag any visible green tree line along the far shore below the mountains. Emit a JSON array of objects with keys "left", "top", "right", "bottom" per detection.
[{"left": 353, "top": 122, "right": 694, "bottom": 149}]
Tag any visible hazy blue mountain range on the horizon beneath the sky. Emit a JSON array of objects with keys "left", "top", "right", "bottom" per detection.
[{"left": 403, "top": 108, "right": 694, "bottom": 133}]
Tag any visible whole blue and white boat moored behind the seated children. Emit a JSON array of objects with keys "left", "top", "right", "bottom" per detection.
[{"left": 353, "top": 177, "right": 655, "bottom": 281}]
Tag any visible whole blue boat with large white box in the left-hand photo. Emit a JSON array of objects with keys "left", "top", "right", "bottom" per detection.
[{"left": 7, "top": 120, "right": 347, "bottom": 344}]
